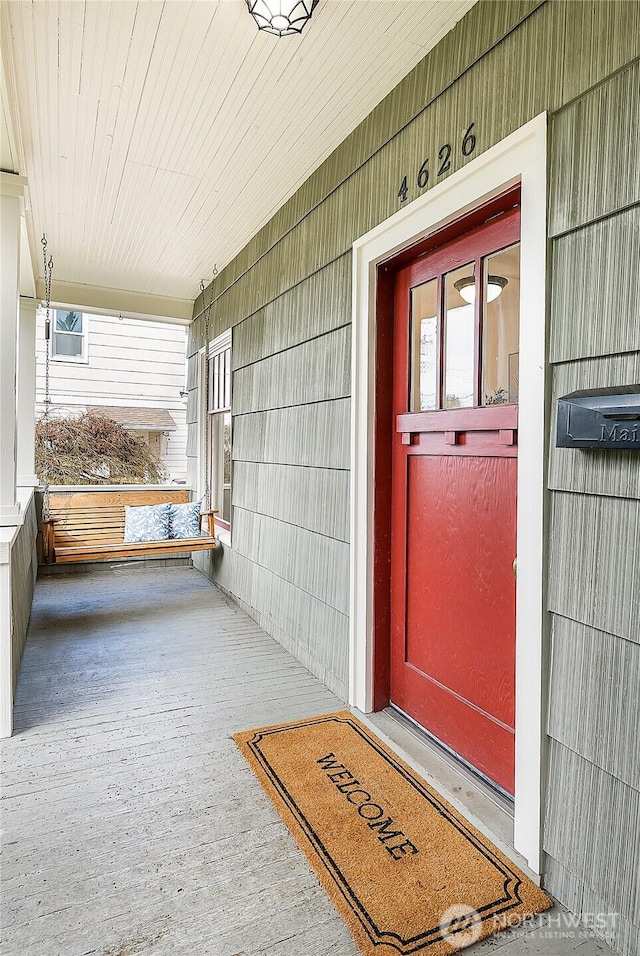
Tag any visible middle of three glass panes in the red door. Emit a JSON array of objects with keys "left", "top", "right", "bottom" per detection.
[{"left": 443, "top": 262, "right": 475, "bottom": 408}]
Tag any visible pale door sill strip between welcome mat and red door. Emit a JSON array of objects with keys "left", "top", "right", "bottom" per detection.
[{"left": 351, "top": 707, "right": 540, "bottom": 884}]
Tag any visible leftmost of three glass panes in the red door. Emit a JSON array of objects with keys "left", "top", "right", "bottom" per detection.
[{"left": 410, "top": 279, "right": 438, "bottom": 412}]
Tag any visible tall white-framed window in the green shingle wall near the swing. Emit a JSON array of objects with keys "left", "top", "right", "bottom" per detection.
[{"left": 207, "top": 330, "right": 231, "bottom": 531}]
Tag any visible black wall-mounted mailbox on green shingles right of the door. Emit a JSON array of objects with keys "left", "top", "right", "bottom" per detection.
[{"left": 556, "top": 385, "right": 640, "bottom": 450}]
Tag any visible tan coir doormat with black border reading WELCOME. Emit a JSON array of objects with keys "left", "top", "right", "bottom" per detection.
[{"left": 234, "top": 711, "right": 552, "bottom": 956}]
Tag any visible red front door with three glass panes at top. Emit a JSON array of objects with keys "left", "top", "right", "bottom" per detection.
[{"left": 390, "top": 207, "right": 520, "bottom": 793}]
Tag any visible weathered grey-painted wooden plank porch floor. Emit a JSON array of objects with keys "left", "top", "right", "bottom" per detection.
[{"left": 1, "top": 565, "right": 610, "bottom": 956}]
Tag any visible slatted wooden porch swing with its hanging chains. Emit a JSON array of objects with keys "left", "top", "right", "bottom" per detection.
[{"left": 42, "top": 243, "right": 222, "bottom": 565}]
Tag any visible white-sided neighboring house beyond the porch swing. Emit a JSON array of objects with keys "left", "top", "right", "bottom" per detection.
[{"left": 36, "top": 308, "right": 187, "bottom": 482}]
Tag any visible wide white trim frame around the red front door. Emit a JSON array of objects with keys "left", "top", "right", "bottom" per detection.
[{"left": 349, "top": 113, "right": 547, "bottom": 874}]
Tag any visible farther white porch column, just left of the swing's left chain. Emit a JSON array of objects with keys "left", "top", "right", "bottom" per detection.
[{"left": 17, "top": 295, "right": 39, "bottom": 488}]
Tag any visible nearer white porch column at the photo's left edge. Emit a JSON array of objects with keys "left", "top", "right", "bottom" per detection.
[{"left": 0, "top": 173, "right": 27, "bottom": 528}]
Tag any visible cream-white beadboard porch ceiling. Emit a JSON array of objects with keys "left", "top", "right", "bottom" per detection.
[{"left": 1, "top": 0, "right": 475, "bottom": 318}]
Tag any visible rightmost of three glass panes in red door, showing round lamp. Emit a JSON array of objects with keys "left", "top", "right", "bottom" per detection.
[{"left": 482, "top": 245, "right": 520, "bottom": 405}]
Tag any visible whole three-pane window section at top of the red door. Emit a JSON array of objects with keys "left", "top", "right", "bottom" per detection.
[{"left": 409, "top": 207, "right": 520, "bottom": 412}]
